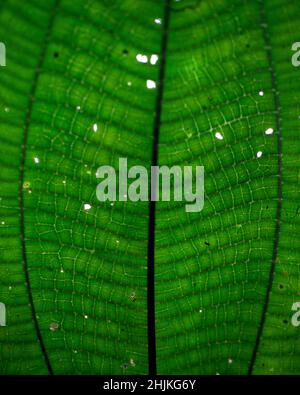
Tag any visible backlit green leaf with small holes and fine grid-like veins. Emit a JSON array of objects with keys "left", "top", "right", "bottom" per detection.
[{"left": 0, "top": 0, "right": 300, "bottom": 374}]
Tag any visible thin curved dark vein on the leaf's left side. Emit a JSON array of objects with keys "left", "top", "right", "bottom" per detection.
[{"left": 19, "top": 0, "right": 60, "bottom": 375}]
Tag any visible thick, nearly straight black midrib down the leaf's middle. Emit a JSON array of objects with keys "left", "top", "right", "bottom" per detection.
[{"left": 148, "top": 0, "right": 170, "bottom": 375}]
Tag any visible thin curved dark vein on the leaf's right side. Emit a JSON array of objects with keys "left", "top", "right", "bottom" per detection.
[{"left": 248, "top": 0, "right": 282, "bottom": 374}]
